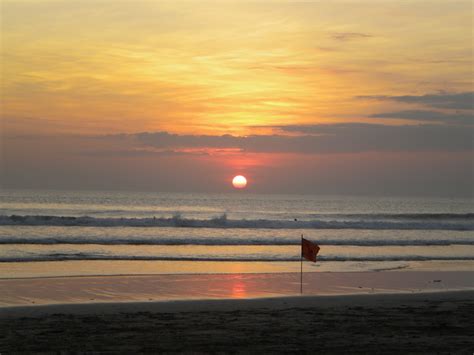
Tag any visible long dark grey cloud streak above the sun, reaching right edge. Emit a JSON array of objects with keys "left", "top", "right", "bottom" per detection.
[{"left": 108, "top": 123, "right": 473, "bottom": 154}]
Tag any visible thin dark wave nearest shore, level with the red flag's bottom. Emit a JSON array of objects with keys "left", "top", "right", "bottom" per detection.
[{"left": 0, "top": 253, "right": 474, "bottom": 262}]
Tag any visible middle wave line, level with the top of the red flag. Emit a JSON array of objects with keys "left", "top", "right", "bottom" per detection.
[{"left": 0, "top": 237, "right": 474, "bottom": 247}]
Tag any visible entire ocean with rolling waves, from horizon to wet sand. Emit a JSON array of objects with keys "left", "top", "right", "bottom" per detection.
[{"left": 0, "top": 190, "right": 474, "bottom": 278}]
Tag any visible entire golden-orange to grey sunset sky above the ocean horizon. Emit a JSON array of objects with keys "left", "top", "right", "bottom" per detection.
[{"left": 0, "top": 0, "right": 474, "bottom": 197}]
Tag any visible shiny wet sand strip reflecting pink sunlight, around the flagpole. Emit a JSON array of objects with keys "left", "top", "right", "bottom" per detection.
[{"left": 0, "top": 271, "right": 474, "bottom": 307}]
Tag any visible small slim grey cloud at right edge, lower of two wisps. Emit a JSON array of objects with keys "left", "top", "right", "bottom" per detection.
[{"left": 369, "top": 110, "right": 474, "bottom": 124}]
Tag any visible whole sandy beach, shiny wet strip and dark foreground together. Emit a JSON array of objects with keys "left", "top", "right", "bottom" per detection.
[{"left": 0, "top": 272, "right": 474, "bottom": 354}]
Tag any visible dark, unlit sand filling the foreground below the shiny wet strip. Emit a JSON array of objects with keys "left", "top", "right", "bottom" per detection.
[{"left": 0, "top": 291, "right": 474, "bottom": 354}]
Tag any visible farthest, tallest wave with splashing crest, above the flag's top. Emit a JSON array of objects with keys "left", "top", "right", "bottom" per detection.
[{"left": 0, "top": 214, "right": 474, "bottom": 230}]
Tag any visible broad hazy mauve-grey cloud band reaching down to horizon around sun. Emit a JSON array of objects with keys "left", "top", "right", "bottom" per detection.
[{"left": 0, "top": 126, "right": 473, "bottom": 196}]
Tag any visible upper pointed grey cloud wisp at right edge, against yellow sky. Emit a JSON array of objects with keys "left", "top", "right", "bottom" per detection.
[{"left": 357, "top": 92, "right": 474, "bottom": 110}]
